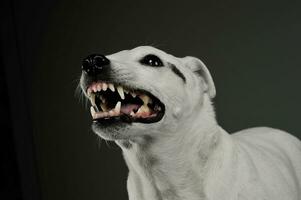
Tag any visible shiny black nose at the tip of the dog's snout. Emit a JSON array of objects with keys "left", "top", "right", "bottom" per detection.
[{"left": 82, "top": 54, "right": 110, "bottom": 76}]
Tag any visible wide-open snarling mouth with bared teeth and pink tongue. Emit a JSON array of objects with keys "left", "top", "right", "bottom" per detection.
[{"left": 87, "top": 81, "right": 165, "bottom": 123}]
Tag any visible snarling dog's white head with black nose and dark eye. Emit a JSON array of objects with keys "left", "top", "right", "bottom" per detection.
[{"left": 80, "top": 46, "right": 215, "bottom": 140}]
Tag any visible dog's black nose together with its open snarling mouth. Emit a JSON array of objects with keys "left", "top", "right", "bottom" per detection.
[{"left": 82, "top": 54, "right": 165, "bottom": 124}]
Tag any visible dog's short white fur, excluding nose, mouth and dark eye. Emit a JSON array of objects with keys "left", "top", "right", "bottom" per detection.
[{"left": 85, "top": 46, "right": 301, "bottom": 200}]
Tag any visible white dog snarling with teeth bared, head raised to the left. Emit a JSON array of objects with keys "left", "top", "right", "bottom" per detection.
[{"left": 81, "top": 46, "right": 301, "bottom": 200}]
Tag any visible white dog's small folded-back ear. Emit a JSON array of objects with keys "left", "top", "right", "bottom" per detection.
[{"left": 183, "top": 56, "right": 216, "bottom": 98}]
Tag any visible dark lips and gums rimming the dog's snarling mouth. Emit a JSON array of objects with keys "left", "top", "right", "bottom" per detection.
[{"left": 85, "top": 80, "right": 165, "bottom": 125}]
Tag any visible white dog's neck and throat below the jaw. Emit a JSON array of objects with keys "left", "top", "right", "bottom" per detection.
[{"left": 117, "top": 95, "right": 237, "bottom": 200}]
